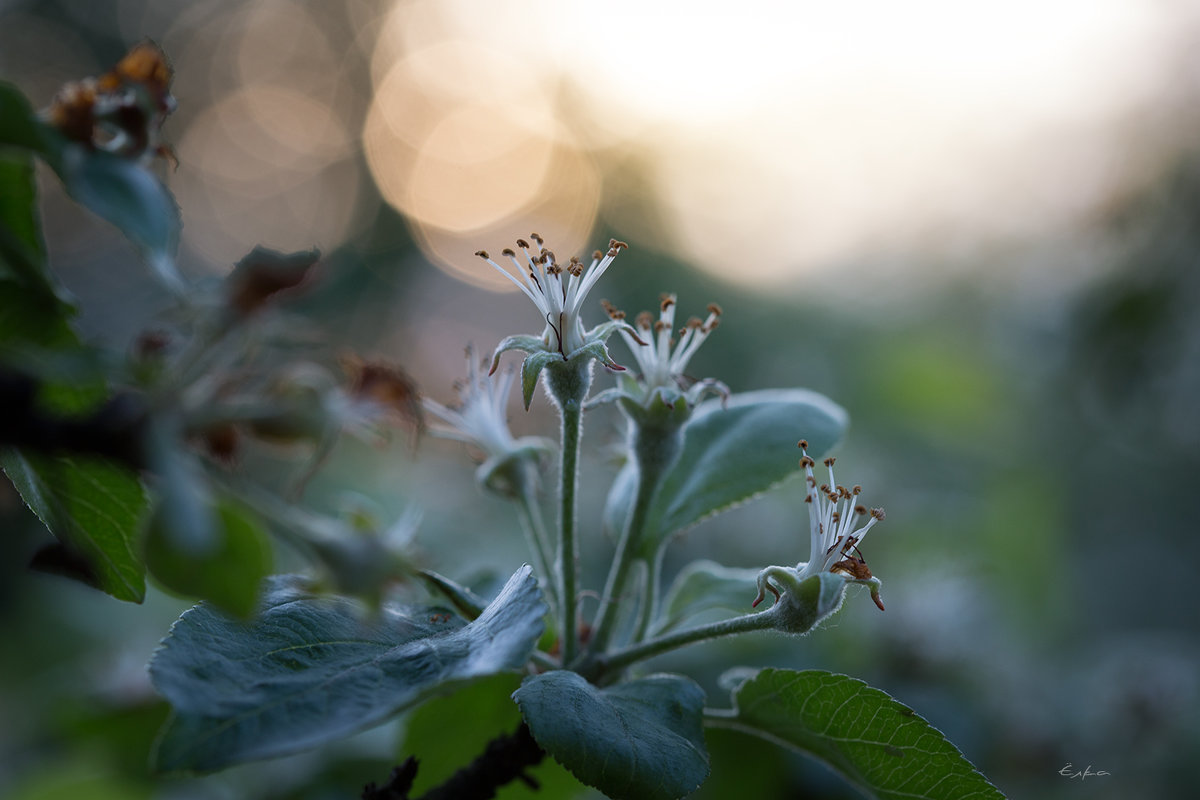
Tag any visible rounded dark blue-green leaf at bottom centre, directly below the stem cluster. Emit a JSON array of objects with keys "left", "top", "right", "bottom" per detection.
[{"left": 514, "top": 670, "right": 708, "bottom": 800}]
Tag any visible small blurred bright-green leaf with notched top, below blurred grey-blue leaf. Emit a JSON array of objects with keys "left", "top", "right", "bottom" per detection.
[{"left": 145, "top": 498, "right": 271, "bottom": 618}]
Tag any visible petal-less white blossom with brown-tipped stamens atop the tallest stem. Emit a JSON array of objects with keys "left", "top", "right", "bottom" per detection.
[{"left": 475, "top": 234, "right": 629, "bottom": 359}]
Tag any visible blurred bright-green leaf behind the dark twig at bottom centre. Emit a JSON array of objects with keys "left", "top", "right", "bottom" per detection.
[{"left": 396, "top": 674, "right": 586, "bottom": 800}]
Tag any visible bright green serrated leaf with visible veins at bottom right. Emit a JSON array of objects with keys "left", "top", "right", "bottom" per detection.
[{"left": 707, "top": 669, "right": 1004, "bottom": 800}]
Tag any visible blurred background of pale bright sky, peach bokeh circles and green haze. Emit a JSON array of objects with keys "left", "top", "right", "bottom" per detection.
[{"left": 0, "top": 0, "right": 1200, "bottom": 800}]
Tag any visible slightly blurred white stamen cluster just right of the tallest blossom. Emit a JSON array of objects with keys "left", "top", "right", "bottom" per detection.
[{"left": 601, "top": 294, "right": 730, "bottom": 405}]
